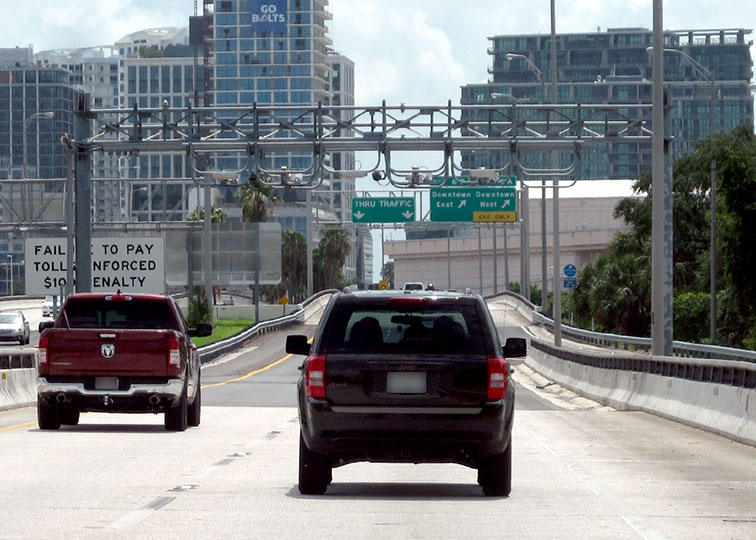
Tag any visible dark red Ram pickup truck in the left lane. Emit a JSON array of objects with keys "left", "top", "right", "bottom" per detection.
[{"left": 37, "top": 293, "right": 212, "bottom": 431}]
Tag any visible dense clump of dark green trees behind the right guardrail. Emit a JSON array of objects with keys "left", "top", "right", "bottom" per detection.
[{"left": 575, "top": 126, "right": 756, "bottom": 346}]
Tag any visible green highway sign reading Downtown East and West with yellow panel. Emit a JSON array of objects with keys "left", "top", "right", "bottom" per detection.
[{"left": 430, "top": 186, "right": 517, "bottom": 223}]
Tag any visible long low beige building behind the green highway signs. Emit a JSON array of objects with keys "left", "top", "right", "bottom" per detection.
[{"left": 383, "top": 197, "right": 627, "bottom": 295}]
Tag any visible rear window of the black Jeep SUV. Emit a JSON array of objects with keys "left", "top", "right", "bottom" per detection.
[{"left": 323, "top": 302, "right": 486, "bottom": 354}]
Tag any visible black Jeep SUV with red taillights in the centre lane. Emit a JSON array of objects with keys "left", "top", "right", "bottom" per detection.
[{"left": 286, "top": 291, "right": 526, "bottom": 496}]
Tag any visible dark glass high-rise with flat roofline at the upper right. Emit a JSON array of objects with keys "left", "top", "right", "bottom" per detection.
[{"left": 462, "top": 28, "right": 754, "bottom": 179}]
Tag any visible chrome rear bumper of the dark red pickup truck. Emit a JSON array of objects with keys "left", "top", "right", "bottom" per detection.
[{"left": 37, "top": 377, "right": 184, "bottom": 412}]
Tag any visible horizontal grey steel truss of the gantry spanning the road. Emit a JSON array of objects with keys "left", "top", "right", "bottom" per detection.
[{"left": 75, "top": 102, "right": 652, "bottom": 188}]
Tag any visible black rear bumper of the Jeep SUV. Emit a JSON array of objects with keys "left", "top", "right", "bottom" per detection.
[{"left": 300, "top": 395, "right": 514, "bottom": 467}]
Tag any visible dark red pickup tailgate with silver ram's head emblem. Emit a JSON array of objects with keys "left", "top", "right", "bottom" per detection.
[{"left": 44, "top": 329, "right": 178, "bottom": 377}]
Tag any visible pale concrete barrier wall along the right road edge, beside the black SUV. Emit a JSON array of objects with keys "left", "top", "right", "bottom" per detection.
[{"left": 525, "top": 347, "right": 756, "bottom": 446}]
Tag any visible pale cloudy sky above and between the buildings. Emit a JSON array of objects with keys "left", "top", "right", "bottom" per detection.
[{"left": 0, "top": 0, "right": 756, "bottom": 276}]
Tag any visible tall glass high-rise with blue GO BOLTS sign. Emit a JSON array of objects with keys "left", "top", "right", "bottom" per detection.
[{"left": 207, "top": 0, "right": 360, "bottom": 281}]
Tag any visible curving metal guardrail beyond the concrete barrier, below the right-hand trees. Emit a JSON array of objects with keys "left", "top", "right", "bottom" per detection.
[{"left": 489, "top": 291, "right": 756, "bottom": 362}]
